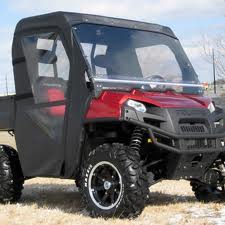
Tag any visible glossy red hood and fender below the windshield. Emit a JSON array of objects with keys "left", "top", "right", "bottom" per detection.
[{"left": 86, "top": 90, "right": 211, "bottom": 119}]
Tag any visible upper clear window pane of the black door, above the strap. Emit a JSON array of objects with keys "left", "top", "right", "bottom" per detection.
[{"left": 22, "top": 33, "right": 70, "bottom": 103}]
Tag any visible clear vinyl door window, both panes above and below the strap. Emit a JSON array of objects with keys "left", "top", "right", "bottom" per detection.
[{"left": 22, "top": 33, "right": 70, "bottom": 142}]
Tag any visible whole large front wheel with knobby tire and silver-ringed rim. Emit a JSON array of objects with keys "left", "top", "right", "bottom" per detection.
[{"left": 81, "top": 144, "right": 148, "bottom": 218}]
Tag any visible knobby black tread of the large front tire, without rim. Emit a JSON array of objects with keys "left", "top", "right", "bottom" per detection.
[{"left": 81, "top": 143, "right": 148, "bottom": 218}]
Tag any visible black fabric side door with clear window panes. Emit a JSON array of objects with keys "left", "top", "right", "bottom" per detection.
[{"left": 15, "top": 32, "right": 71, "bottom": 177}]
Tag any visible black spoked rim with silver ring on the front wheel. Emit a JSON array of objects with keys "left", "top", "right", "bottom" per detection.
[{"left": 88, "top": 161, "right": 122, "bottom": 210}]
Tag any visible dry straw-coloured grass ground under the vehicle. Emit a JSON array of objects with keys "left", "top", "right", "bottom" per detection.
[{"left": 0, "top": 134, "right": 225, "bottom": 225}]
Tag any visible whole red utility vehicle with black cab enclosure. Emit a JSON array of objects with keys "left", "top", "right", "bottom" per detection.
[{"left": 0, "top": 12, "right": 225, "bottom": 217}]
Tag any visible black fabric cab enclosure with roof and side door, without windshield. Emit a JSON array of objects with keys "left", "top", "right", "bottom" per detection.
[{"left": 9, "top": 12, "right": 178, "bottom": 177}]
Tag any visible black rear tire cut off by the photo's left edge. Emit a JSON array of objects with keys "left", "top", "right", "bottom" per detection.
[{"left": 0, "top": 146, "right": 24, "bottom": 203}]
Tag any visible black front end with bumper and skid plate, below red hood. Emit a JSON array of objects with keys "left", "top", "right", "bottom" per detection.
[{"left": 123, "top": 107, "right": 225, "bottom": 180}]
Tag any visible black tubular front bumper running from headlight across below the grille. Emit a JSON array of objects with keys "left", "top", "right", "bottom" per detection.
[{"left": 124, "top": 108, "right": 225, "bottom": 154}]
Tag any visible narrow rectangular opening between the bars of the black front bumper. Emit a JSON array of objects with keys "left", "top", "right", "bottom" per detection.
[{"left": 184, "top": 139, "right": 216, "bottom": 150}]
